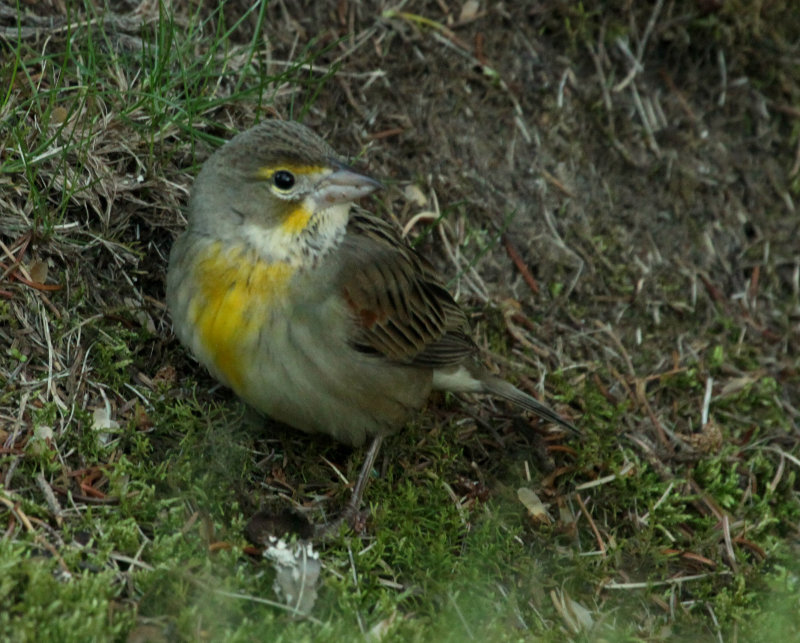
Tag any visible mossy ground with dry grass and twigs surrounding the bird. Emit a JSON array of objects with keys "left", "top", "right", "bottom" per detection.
[{"left": 0, "top": 0, "right": 800, "bottom": 640}]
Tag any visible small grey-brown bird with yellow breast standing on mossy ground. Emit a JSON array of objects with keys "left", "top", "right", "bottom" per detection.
[{"left": 166, "top": 118, "right": 577, "bottom": 532}]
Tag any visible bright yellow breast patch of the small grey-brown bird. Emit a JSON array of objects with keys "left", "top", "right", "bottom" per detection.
[{"left": 189, "top": 242, "right": 294, "bottom": 392}]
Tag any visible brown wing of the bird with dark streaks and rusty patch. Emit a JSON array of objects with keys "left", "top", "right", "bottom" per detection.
[{"left": 339, "top": 211, "right": 475, "bottom": 368}]
